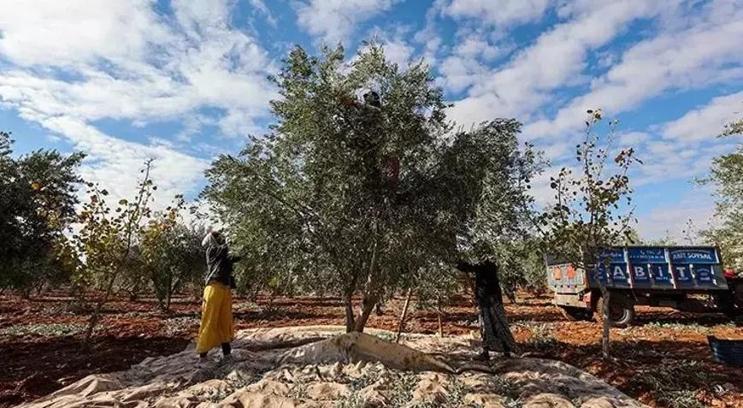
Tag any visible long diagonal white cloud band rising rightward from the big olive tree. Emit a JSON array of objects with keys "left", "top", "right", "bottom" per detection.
[{"left": 451, "top": 0, "right": 676, "bottom": 124}]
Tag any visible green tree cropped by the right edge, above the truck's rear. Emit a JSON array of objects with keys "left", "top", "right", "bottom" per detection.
[{"left": 701, "top": 119, "right": 743, "bottom": 273}]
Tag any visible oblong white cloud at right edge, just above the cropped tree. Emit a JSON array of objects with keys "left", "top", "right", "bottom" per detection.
[{"left": 662, "top": 91, "right": 743, "bottom": 142}]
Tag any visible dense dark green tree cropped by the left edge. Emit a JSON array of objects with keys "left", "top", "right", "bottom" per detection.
[{"left": 0, "top": 132, "right": 84, "bottom": 296}]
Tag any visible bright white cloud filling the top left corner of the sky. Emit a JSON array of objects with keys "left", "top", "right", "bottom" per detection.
[{"left": 0, "top": 0, "right": 169, "bottom": 66}]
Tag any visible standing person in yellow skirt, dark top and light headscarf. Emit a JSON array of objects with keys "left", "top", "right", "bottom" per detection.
[{"left": 196, "top": 230, "right": 240, "bottom": 359}]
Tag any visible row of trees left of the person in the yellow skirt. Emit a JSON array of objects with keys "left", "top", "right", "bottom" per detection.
[{"left": 0, "top": 132, "right": 204, "bottom": 316}]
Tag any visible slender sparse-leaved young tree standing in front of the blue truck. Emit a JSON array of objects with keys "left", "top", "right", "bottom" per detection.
[{"left": 545, "top": 110, "right": 639, "bottom": 357}]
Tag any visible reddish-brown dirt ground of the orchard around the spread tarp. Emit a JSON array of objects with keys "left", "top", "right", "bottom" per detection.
[{"left": 0, "top": 294, "right": 743, "bottom": 407}]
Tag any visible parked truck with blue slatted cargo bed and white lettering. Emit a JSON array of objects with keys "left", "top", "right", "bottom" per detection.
[{"left": 545, "top": 246, "right": 743, "bottom": 327}]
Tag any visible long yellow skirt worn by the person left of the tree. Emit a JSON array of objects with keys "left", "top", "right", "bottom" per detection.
[{"left": 196, "top": 282, "right": 234, "bottom": 354}]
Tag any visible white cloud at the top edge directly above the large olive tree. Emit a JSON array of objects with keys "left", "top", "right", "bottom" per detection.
[{"left": 296, "top": 0, "right": 397, "bottom": 46}]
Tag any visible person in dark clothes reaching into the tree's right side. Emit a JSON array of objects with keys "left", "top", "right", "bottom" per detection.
[{"left": 457, "top": 261, "right": 516, "bottom": 360}]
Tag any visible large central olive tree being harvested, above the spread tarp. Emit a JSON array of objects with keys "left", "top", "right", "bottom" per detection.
[{"left": 204, "top": 44, "right": 530, "bottom": 331}]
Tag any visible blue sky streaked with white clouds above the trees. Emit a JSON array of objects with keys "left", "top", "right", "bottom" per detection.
[{"left": 0, "top": 0, "right": 743, "bottom": 239}]
